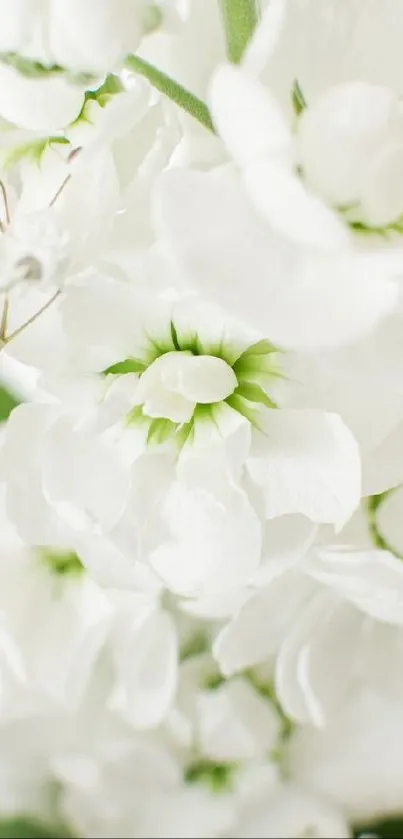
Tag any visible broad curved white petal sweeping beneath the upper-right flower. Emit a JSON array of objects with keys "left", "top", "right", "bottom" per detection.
[{"left": 156, "top": 170, "right": 401, "bottom": 349}]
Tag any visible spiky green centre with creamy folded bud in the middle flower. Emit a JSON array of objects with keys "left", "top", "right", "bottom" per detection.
[{"left": 113, "top": 320, "right": 282, "bottom": 449}]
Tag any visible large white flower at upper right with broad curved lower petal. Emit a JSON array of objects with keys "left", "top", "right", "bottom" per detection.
[{"left": 157, "top": 40, "right": 403, "bottom": 350}]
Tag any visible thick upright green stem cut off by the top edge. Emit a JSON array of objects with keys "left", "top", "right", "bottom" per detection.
[{"left": 219, "top": 0, "right": 258, "bottom": 64}]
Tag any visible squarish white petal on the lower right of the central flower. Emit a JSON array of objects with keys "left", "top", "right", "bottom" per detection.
[{"left": 247, "top": 410, "right": 361, "bottom": 523}]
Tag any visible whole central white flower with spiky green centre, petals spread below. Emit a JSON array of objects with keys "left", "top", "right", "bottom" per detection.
[{"left": 3, "top": 276, "right": 360, "bottom": 596}]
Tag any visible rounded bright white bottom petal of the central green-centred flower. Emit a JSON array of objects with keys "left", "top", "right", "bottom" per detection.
[{"left": 150, "top": 461, "right": 261, "bottom": 596}]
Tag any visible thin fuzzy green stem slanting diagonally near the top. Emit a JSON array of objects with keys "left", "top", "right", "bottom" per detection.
[{"left": 125, "top": 55, "right": 214, "bottom": 131}]
